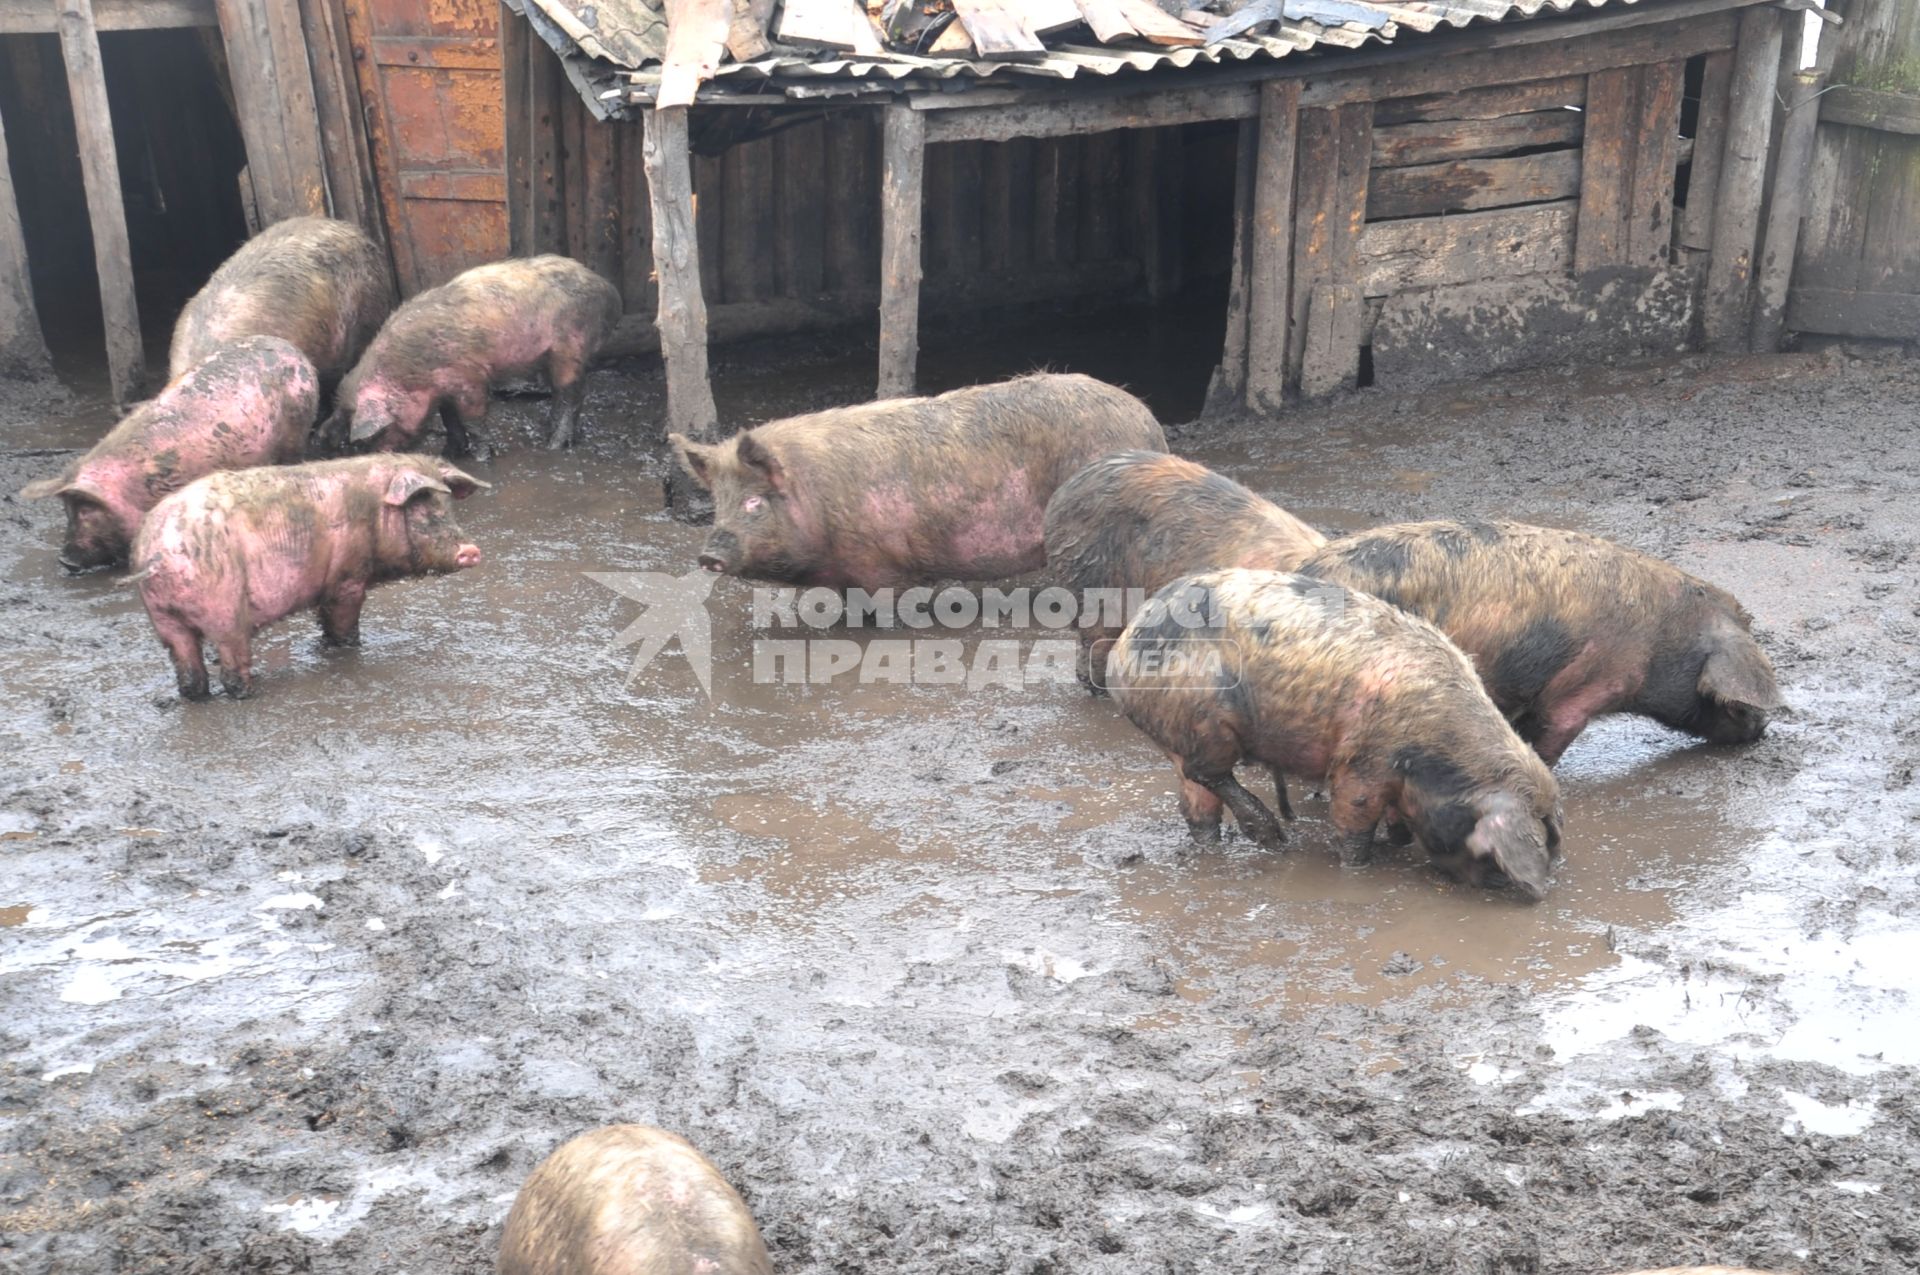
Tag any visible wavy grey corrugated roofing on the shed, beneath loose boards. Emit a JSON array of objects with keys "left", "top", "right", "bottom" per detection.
[{"left": 507, "top": 0, "right": 1661, "bottom": 115}]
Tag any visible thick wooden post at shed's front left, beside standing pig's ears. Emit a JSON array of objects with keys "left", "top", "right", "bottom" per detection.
[{"left": 641, "top": 106, "right": 720, "bottom": 513}]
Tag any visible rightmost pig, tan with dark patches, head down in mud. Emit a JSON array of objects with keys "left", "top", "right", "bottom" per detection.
[{"left": 1300, "top": 522, "right": 1780, "bottom": 766}]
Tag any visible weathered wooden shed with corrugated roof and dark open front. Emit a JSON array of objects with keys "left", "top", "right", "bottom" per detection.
[{"left": 501, "top": 0, "right": 1809, "bottom": 458}]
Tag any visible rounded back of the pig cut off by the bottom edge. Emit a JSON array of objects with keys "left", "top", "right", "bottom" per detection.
[{"left": 493, "top": 1125, "right": 774, "bottom": 1275}]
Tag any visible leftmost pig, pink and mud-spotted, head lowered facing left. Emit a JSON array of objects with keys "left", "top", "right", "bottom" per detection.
[{"left": 19, "top": 336, "right": 321, "bottom": 570}]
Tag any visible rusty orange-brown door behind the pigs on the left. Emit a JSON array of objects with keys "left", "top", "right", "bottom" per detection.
[{"left": 346, "top": 0, "right": 507, "bottom": 296}]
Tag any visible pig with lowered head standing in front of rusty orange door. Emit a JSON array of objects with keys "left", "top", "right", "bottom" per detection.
[{"left": 324, "top": 255, "right": 620, "bottom": 455}]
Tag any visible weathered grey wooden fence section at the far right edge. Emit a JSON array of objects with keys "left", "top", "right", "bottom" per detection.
[{"left": 1788, "top": 0, "right": 1920, "bottom": 340}]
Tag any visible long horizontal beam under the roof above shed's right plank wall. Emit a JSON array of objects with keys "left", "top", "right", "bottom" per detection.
[{"left": 1300, "top": 9, "right": 1753, "bottom": 108}]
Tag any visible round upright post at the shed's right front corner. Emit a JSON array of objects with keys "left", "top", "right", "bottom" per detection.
[{"left": 1703, "top": 8, "right": 1799, "bottom": 349}]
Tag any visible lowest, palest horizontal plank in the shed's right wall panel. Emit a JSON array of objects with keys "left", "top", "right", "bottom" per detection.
[{"left": 1351, "top": 200, "right": 1578, "bottom": 296}]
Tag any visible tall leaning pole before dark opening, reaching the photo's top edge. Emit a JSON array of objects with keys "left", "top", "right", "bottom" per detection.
[{"left": 60, "top": 0, "right": 146, "bottom": 405}]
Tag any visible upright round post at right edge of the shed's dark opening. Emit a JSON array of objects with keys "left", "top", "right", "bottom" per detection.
[{"left": 1229, "top": 79, "right": 1305, "bottom": 413}]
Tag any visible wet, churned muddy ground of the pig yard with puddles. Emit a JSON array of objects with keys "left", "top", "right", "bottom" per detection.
[{"left": 0, "top": 332, "right": 1920, "bottom": 1275}]
